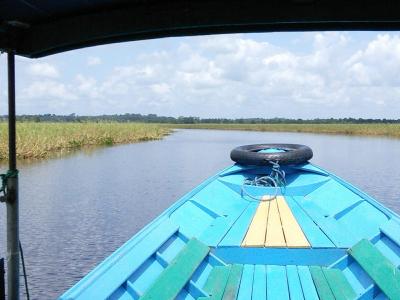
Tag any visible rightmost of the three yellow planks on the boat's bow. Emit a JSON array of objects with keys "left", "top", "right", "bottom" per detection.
[{"left": 277, "top": 196, "right": 310, "bottom": 248}]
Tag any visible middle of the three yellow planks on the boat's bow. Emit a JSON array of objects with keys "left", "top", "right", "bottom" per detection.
[{"left": 265, "top": 198, "right": 286, "bottom": 247}]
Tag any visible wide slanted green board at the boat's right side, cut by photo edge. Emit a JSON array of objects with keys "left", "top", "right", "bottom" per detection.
[{"left": 349, "top": 239, "right": 400, "bottom": 300}]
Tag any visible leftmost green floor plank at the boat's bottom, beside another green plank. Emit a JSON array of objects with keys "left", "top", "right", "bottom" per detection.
[{"left": 199, "top": 266, "right": 231, "bottom": 300}]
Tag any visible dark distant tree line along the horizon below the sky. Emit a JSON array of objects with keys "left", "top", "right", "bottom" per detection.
[{"left": 0, "top": 113, "right": 400, "bottom": 124}]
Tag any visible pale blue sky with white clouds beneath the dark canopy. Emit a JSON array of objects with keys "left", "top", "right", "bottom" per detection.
[{"left": 0, "top": 32, "right": 400, "bottom": 119}]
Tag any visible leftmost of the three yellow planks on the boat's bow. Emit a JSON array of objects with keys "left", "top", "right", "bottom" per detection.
[{"left": 242, "top": 196, "right": 269, "bottom": 247}]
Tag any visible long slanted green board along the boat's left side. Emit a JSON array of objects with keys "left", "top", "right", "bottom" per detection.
[{"left": 140, "top": 239, "right": 210, "bottom": 300}]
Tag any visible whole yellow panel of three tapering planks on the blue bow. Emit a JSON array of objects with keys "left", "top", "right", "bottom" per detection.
[{"left": 242, "top": 195, "right": 310, "bottom": 248}]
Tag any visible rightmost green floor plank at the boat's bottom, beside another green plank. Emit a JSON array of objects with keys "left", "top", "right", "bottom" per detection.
[{"left": 322, "top": 267, "right": 356, "bottom": 300}]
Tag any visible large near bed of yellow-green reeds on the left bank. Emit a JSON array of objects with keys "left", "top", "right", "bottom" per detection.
[{"left": 0, "top": 122, "right": 172, "bottom": 160}]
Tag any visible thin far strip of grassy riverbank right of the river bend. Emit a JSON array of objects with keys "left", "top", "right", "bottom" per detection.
[{"left": 169, "top": 123, "right": 400, "bottom": 138}]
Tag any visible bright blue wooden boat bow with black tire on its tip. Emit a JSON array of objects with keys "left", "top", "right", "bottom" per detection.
[{"left": 60, "top": 145, "right": 400, "bottom": 300}]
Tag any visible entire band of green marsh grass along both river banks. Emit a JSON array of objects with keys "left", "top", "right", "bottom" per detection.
[{"left": 0, "top": 122, "right": 400, "bottom": 160}]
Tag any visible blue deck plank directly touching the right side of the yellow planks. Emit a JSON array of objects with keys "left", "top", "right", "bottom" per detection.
[{"left": 285, "top": 197, "right": 335, "bottom": 248}]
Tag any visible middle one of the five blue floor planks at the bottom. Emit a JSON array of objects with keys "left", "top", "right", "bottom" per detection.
[{"left": 267, "top": 266, "right": 289, "bottom": 300}]
